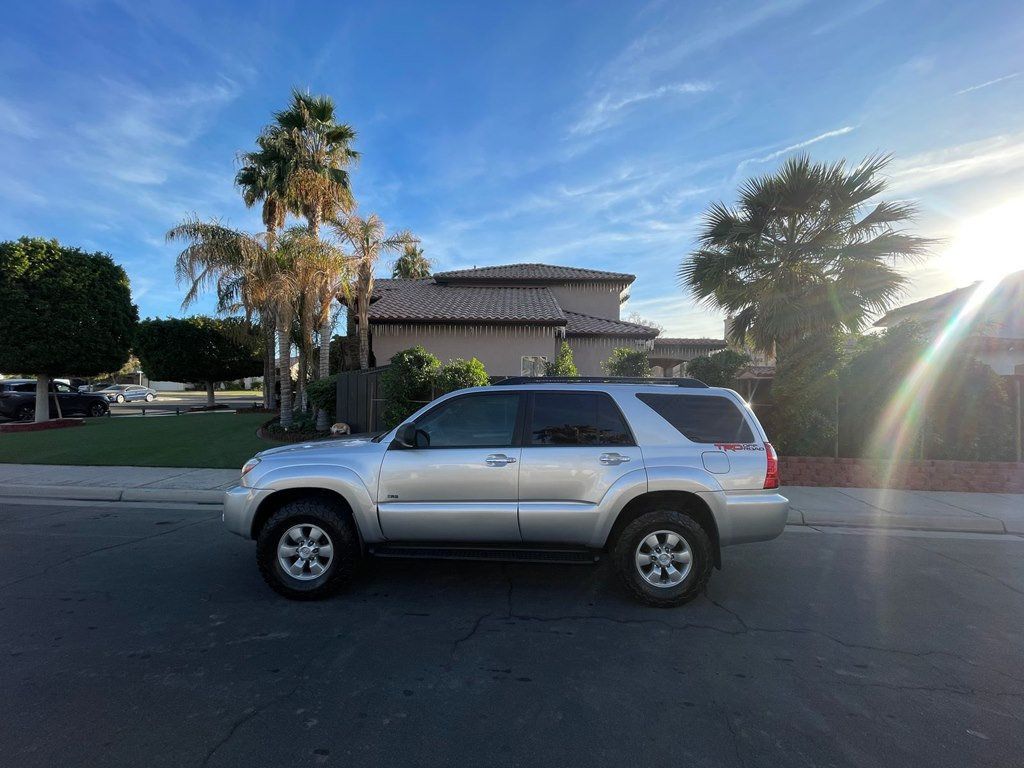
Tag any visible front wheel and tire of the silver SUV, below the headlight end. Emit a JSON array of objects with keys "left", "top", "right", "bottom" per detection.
[{"left": 256, "top": 498, "right": 358, "bottom": 600}]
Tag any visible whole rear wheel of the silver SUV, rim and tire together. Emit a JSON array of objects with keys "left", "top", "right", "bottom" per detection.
[{"left": 614, "top": 510, "right": 714, "bottom": 608}]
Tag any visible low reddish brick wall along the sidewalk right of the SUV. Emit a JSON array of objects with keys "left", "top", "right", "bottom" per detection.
[{"left": 779, "top": 456, "right": 1024, "bottom": 494}]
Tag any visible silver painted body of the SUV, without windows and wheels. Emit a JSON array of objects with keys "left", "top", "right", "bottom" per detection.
[{"left": 224, "top": 380, "right": 788, "bottom": 548}]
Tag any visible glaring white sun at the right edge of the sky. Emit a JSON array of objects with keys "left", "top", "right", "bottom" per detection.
[{"left": 941, "top": 197, "right": 1024, "bottom": 285}]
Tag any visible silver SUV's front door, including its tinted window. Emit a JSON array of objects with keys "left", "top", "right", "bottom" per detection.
[{"left": 377, "top": 392, "right": 522, "bottom": 544}]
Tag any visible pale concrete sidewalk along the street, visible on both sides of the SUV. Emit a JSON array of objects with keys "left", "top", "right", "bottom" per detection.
[{"left": 0, "top": 464, "right": 1024, "bottom": 535}]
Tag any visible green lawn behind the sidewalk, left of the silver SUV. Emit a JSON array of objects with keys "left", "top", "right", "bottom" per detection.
[{"left": 0, "top": 414, "right": 281, "bottom": 469}]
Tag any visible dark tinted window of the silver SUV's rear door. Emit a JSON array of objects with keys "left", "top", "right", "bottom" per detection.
[{"left": 528, "top": 392, "right": 633, "bottom": 445}]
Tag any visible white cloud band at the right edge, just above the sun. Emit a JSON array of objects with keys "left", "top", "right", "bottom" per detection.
[{"left": 889, "top": 133, "right": 1024, "bottom": 194}]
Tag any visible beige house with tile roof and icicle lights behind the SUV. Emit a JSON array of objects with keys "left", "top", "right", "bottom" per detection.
[{"left": 369, "top": 264, "right": 725, "bottom": 376}]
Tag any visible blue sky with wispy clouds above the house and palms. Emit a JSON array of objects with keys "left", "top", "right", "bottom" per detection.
[{"left": 0, "top": 0, "right": 1024, "bottom": 336}]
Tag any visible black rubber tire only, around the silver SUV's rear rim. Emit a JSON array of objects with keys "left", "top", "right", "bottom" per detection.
[{"left": 613, "top": 509, "right": 714, "bottom": 608}]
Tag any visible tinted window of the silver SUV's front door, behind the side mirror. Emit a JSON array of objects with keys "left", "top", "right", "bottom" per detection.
[{"left": 416, "top": 392, "right": 519, "bottom": 447}]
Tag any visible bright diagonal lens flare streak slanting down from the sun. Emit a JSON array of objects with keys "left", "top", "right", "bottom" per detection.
[{"left": 868, "top": 280, "right": 999, "bottom": 487}]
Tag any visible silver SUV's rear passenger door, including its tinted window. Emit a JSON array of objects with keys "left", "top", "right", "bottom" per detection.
[{"left": 519, "top": 391, "right": 643, "bottom": 544}]
